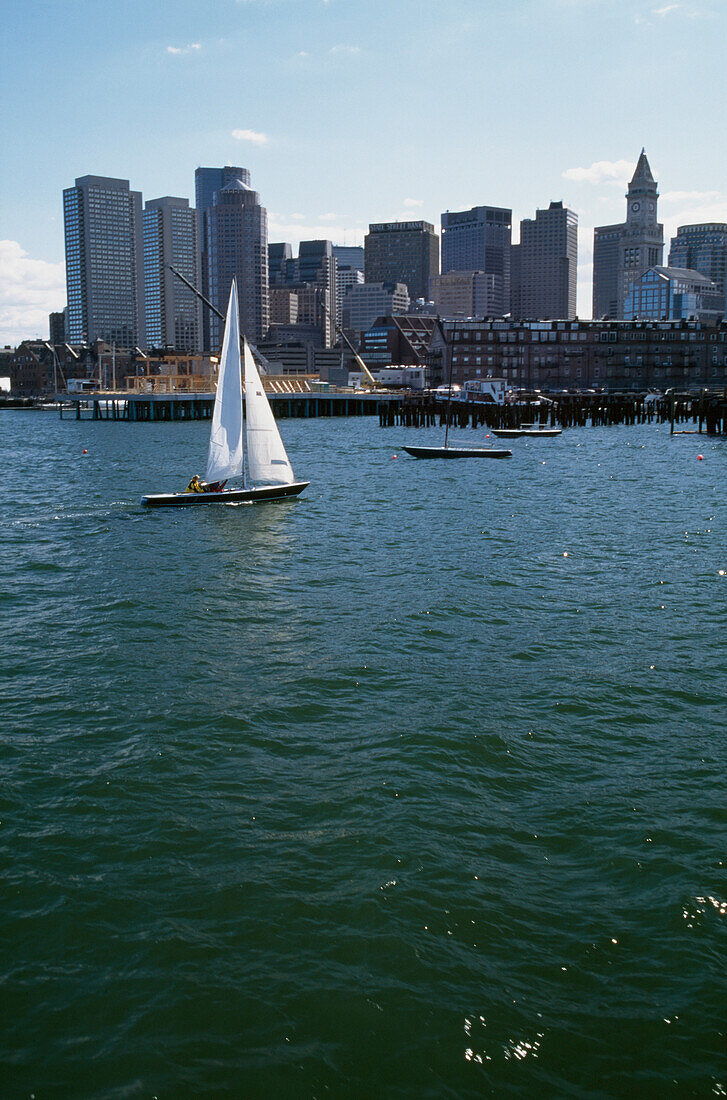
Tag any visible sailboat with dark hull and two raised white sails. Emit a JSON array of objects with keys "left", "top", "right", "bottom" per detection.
[{"left": 142, "top": 279, "right": 310, "bottom": 508}]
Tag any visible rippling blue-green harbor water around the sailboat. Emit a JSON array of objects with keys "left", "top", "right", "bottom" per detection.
[{"left": 0, "top": 413, "right": 727, "bottom": 1100}]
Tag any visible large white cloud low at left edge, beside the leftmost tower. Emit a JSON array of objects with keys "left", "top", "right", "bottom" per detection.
[{"left": 0, "top": 241, "right": 66, "bottom": 344}]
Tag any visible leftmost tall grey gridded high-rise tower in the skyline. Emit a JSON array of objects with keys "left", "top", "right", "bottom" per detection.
[{"left": 63, "top": 176, "right": 145, "bottom": 348}]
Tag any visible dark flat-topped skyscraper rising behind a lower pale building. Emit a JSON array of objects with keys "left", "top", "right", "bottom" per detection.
[{"left": 442, "top": 207, "right": 513, "bottom": 317}]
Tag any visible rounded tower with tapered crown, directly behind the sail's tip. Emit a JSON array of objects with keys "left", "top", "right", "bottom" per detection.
[{"left": 205, "top": 179, "right": 269, "bottom": 348}]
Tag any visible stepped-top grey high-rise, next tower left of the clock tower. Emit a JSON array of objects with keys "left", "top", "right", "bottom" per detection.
[{"left": 510, "top": 202, "right": 579, "bottom": 320}]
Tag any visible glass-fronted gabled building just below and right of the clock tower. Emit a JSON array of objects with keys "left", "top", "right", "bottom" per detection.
[{"left": 624, "top": 267, "right": 725, "bottom": 321}]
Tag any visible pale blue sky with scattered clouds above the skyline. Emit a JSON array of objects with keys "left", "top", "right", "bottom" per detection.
[{"left": 0, "top": 0, "right": 727, "bottom": 347}]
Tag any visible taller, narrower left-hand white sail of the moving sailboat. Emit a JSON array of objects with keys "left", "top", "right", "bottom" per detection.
[{"left": 205, "top": 279, "right": 242, "bottom": 482}]
